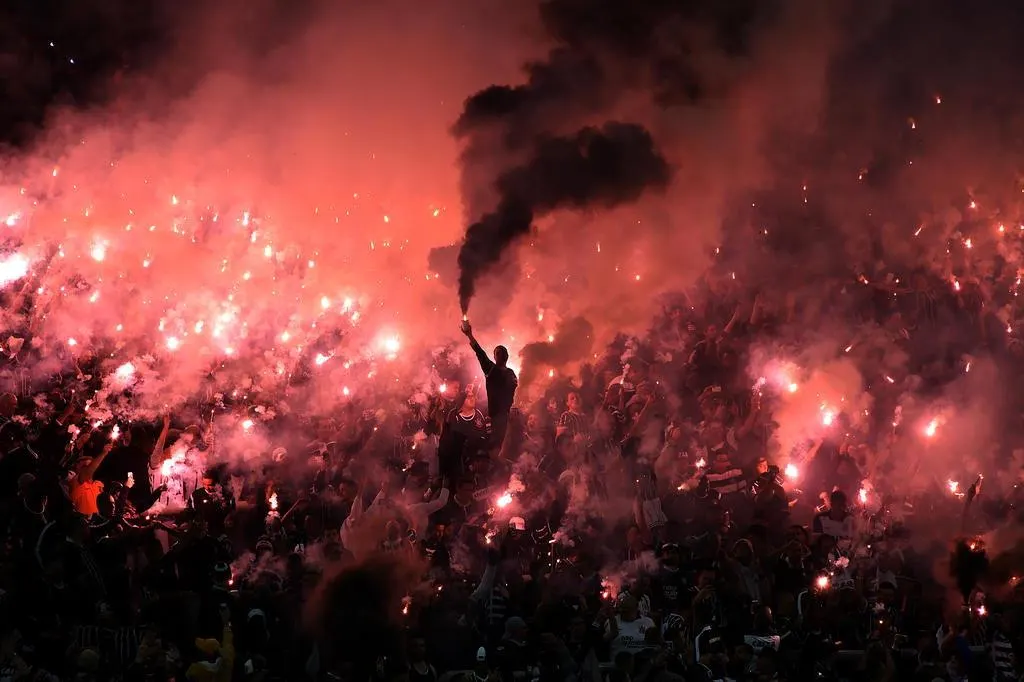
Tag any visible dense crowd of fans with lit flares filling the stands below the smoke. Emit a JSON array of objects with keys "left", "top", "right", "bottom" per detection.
[{"left": 0, "top": 278, "right": 1024, "bottom": 682}]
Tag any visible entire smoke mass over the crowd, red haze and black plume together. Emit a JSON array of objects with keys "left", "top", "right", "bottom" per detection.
[{"left": 6, "top": 0, "right": 1024, "bottom": 524}]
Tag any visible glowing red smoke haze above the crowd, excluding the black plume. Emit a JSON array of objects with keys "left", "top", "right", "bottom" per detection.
[{"left": 2, "top": 0, "right": 1021, "bottom": 475}]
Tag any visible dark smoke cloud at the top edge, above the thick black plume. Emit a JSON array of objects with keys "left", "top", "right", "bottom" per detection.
[{"left": 455, "top": 0, "right": 776, "bottom": 140}]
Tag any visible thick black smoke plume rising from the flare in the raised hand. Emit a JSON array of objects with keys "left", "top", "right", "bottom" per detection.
[{"left": 459, "top": 123, "right": 672, "bottom": 312}]
